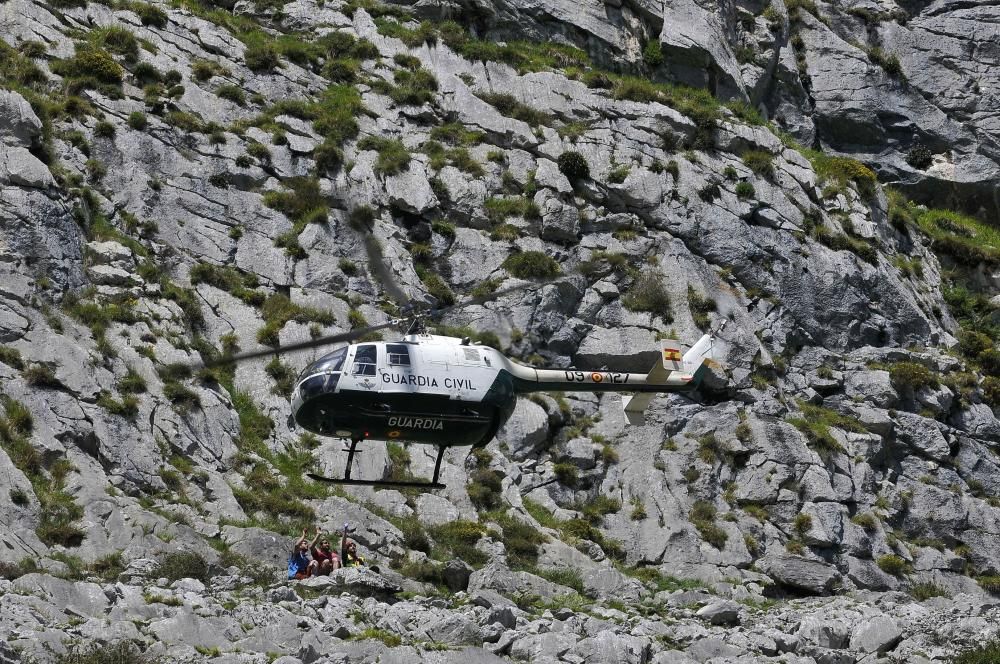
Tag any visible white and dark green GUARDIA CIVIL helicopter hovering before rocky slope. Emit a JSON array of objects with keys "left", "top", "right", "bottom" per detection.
[{"left": 213, "top": 286, "right": 725, "bottom": 489}]
